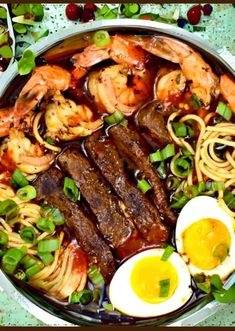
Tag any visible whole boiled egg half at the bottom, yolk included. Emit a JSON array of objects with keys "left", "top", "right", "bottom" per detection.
[{"left": 109, "top": 248, "right": 192, "bottom": 317}]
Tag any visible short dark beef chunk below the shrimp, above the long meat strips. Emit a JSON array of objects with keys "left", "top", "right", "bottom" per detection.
[{"left": 136, "top": 101, "right": 172, "bottom": 148}]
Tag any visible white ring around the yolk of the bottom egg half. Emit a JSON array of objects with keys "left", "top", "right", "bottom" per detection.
[{"left": 109, "top": 248, "right": 192, "bottom": 317}]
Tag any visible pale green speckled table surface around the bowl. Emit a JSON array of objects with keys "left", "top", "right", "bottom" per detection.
[{"left": 0, "top": 4, "right": 235, "bottom": 326}]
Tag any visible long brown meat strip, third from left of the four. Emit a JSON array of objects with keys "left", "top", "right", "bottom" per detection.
[{"left": 85, "top": 133, "right": 169, "bottom": 244}]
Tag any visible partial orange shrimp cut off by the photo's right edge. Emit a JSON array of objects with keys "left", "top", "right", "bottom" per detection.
[{"left": 220, "top": 74, "right": 235, "bottom": 113}]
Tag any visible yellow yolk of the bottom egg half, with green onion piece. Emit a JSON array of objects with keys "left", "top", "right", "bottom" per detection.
[{"left": 131, "top": 256, "right": 178, "bottom": 304}]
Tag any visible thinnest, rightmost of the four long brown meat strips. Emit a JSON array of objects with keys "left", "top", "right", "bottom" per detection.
[{"left": 109, "top": 125, "right": 176, "bottom": 224}]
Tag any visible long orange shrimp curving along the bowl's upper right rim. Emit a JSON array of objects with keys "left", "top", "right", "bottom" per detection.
[{"left": 128, "top": 36, "right": 220, "bottom": 106}]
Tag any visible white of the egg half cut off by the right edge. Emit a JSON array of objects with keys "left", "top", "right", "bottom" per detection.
[{"left": 175, "top": 196, "right": 235, "bottom": 280}]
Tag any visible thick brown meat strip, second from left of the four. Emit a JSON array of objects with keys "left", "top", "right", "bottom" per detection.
[{"left": 58, "top": 147, "right": 135, "bottom": 248}]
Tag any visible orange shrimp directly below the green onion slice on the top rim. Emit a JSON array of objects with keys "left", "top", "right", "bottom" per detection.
[{"left": 72, "top": 35, "right": 148, "bottom": 80}]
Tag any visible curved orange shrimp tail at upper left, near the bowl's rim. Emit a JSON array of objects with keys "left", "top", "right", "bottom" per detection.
[{"left": 13, "top": 65, "right": 71, "bottom": 126}]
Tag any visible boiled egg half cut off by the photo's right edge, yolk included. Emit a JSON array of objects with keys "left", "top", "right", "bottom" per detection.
[{"left": 175, "top": 196, "right": 235, "bottom": 280}]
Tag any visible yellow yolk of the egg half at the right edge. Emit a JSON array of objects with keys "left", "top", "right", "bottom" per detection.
[{"left": 182, "top": 218, "right": 231, "bottom": 270}]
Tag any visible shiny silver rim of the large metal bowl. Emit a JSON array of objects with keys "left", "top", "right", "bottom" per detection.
[{"left": 0, "top": 19, "right": 235, "bottom": 326}]
